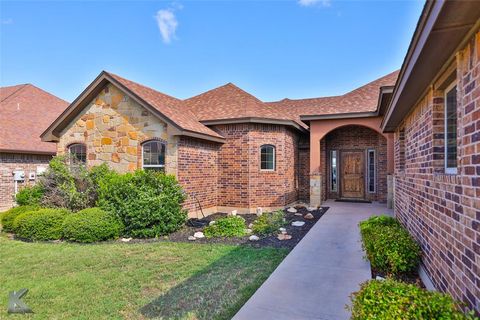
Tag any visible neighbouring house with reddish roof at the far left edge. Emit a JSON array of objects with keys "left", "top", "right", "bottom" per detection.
[{"left": 0, "top": 84, "right": 68, "bottom": 211}]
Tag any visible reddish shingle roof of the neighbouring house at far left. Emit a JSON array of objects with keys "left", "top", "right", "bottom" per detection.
[{"left": 0, "top": 84, "right": 68, "bottom": 154}]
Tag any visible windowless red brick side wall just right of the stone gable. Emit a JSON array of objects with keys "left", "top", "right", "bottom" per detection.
[{"left": 177, "top": 137, "right": 220, "bottom": 211}]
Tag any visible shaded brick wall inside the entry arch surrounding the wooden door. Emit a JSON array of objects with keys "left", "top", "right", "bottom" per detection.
[{"left": 321, "top": 126, "right": 387, "bottom": 202}]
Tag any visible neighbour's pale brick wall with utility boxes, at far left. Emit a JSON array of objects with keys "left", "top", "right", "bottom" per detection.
[{"left": 0, "top": 153, "right": 52, "bottom": 211}]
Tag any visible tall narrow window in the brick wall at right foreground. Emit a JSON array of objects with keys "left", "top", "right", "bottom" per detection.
[{"left": 444, "top": 82, "right": 457, "bottom": 174}]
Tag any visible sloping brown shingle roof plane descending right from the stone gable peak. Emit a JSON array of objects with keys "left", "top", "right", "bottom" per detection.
[{"left": 105, "top": 72, "right": 223, "bottom": 138}]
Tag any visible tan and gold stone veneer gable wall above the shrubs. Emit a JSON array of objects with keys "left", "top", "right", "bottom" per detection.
[{"left": 57, "top": 84, "right": 178, "bottom": 174}]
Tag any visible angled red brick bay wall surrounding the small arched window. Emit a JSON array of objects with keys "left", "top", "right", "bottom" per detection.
[{"left": 211, "top": 124, "right": 308, "bottom": 208}]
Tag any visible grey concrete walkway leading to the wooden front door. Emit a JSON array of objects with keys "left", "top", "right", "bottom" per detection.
[{"left": 233, "top": 201, "right": 392, "bottom": 320}]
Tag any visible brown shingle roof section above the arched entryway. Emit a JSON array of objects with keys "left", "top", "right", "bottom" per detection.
[{"left": 267, "top": 70, "right": 398, "bottom": 117}]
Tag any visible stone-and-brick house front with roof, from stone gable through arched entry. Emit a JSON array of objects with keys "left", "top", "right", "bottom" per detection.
[{"left": 42, "top": 72, "right": 397, "bottom": 215}]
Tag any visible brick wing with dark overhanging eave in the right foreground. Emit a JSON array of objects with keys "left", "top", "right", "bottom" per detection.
[{"left": 382, "top": 1, "right": 480, "bottom": 312}]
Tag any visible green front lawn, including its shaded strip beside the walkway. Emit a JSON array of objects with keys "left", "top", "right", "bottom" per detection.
[{"left": 0, "top": 235, "right": 287, "bottom": 319}]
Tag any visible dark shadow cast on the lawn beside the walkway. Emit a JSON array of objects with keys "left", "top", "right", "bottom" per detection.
[{"left": 139, "top": 247, "right": 283, "bottom": 320}]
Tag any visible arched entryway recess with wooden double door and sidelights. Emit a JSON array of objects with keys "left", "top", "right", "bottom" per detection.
[{"left": 320, "top": 125, "right": 387, "bottom": 202}]
